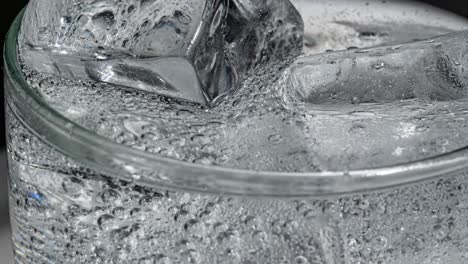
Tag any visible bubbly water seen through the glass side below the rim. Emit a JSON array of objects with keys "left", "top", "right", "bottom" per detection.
[{"left": 8, "top": 104, "right": 468, "bottom": 264}]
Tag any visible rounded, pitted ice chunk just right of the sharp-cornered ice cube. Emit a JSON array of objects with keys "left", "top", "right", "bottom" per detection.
[{"left": 226, "top": 0, "right": 304, "bottom": 79}]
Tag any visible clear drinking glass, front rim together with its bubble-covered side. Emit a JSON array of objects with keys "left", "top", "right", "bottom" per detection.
[{"left": 5, "top": 2, "right": 468, "bottom": 264}]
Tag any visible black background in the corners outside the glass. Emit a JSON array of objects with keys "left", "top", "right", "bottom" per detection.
[{"left": 0, "top": 0, "right": 468, "bottom": 147}]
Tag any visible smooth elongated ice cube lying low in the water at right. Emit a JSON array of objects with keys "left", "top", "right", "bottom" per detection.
[{"left": 289, "top": 31, "right": 468, "bottom": 104}]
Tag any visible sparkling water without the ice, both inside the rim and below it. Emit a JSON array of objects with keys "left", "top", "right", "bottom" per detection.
[{"left": 7, "top": 1, "right": 468, "bottom": 264}]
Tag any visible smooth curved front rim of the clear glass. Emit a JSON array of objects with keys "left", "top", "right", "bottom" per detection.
[{"left": 4, "top": 10, "right": 468, "bottom": 198}]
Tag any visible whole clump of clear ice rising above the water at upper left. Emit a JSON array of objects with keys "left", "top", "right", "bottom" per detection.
[{"left": 20, "top": 0, "right": 303, "bottom": 104}]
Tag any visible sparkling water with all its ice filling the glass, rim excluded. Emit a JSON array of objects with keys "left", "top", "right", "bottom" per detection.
[{"left": 7, "top": 0, "right": 468, "bottom": 264}]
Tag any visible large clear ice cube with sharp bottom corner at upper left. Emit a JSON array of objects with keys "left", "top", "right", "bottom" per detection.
[{"left": 20, "top": 0, "right": 230, "bottom": 103}]
